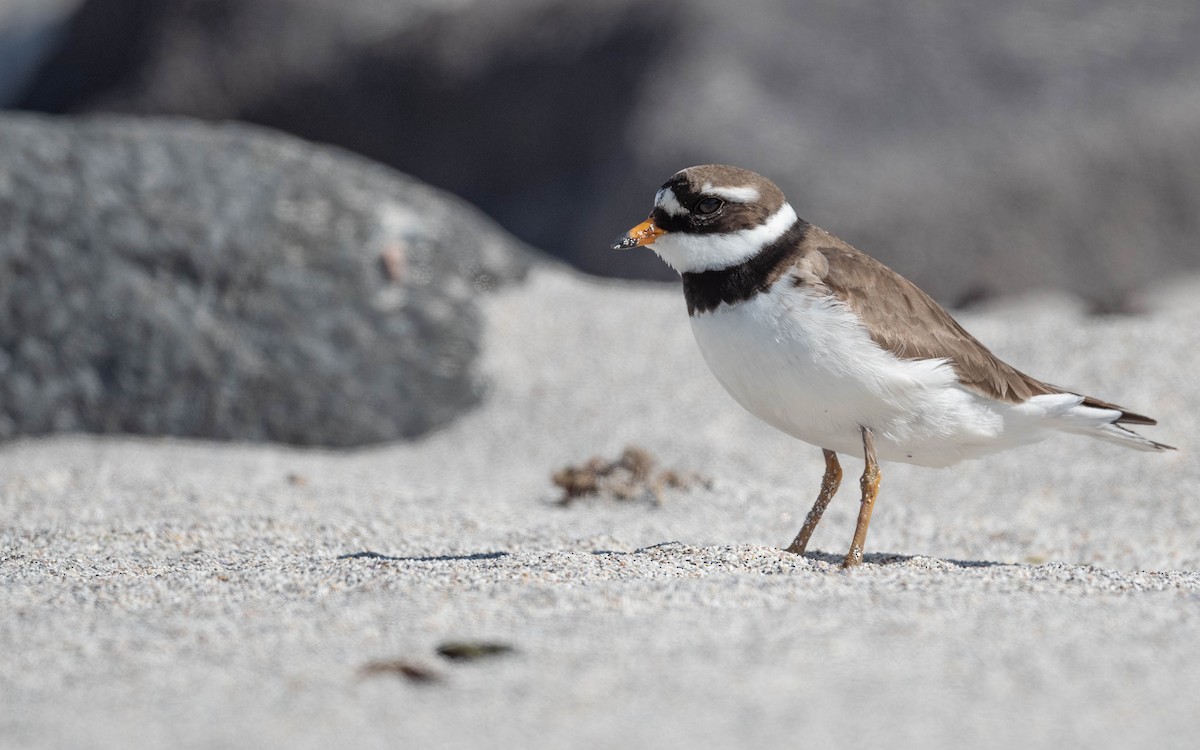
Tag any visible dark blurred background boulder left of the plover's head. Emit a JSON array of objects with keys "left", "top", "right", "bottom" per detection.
[{"left": 11, "top": 0, "right": 678, "bottom": 277}]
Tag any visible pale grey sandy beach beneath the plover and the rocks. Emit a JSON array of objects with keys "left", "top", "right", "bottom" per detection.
[{"left": 0, "top": 269, "right": 1200, "bottom": 750}]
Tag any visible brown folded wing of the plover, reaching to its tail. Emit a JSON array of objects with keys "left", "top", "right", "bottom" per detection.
[{"left": 805, "top": 228, "right": 1137, "bottom": 412}]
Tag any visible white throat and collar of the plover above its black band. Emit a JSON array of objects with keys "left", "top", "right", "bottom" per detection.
[{"left": 649, "top": 203, "right": 796, "bottom": 274}]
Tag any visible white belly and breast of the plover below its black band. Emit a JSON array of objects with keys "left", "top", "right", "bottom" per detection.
[{"left": 691, "top": 283, "right": 1022, "bottom": 466}]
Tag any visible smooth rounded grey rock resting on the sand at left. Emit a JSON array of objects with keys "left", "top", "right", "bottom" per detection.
[{"left": 0, "top": 115, "right": 534, "bottom": 446}]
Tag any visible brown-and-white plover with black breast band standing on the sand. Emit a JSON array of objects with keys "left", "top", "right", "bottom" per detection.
[{"left": 613, "top": 164, "right": 1172, "bottom": 568}]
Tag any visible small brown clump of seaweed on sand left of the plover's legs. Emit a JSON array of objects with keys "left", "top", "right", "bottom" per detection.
[{"left": 551, "top": 445, "right": 712, "bottom": 505}]
